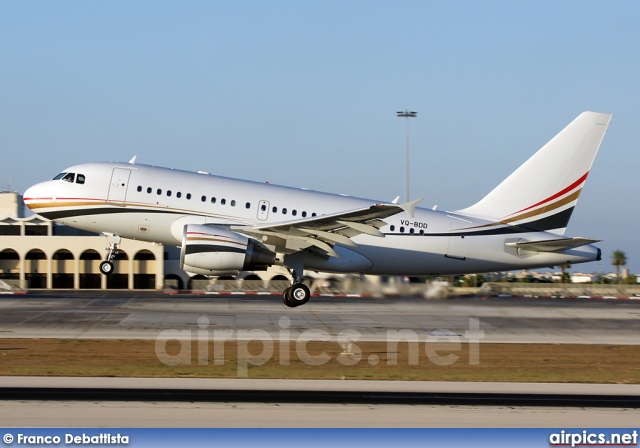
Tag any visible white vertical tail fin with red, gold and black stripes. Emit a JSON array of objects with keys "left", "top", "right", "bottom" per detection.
[{"left": 457, "top": 112, "right": 611, "bottom": 234}]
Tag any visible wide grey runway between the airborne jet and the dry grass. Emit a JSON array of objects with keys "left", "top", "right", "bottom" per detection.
[{"left": 0, "top": 292, "right": 640, "bottom": 345}]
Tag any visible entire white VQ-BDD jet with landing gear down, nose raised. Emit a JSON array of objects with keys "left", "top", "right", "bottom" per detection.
[{"left": 24, "top": 112, "right": 611, "bottom": 307}]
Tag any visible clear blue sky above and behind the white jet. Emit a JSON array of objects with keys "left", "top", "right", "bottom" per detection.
[{"left": 0, "top": 0, "right": 640, "bottom": 273}]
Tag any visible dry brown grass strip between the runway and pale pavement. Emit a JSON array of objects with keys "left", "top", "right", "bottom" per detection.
[{"left": 0, "top": 339, "right": 640, "bottom": 384}]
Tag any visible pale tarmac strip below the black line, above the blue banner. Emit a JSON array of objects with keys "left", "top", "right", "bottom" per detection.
[{"left": 0, "top": 401, "right": 640, "bottom": 428}]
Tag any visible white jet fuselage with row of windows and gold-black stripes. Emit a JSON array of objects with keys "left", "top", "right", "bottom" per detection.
[{"left": 25, "top": 163, "right": 599, "bottom": 275}]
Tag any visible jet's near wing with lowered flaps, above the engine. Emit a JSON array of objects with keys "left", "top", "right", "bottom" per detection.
[{"left": 231, "top": 199, "right": 422, "bottom": 257}]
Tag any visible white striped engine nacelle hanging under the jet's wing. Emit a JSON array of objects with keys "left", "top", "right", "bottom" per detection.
[{"left": 180, "top": 224, "right": 276, "bottom": 276}]
